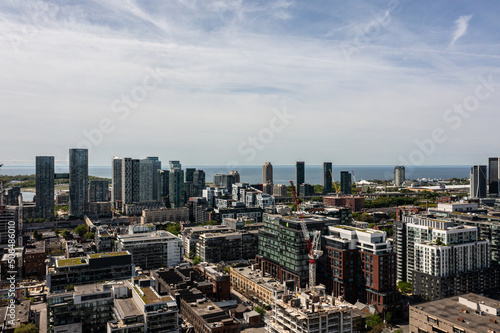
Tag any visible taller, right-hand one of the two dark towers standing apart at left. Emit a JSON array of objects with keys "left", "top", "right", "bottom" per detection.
[{"left": 69, "top": 148, "right": 89, "bottom": 218}]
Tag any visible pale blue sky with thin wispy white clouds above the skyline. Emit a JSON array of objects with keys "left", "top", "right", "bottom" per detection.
[{"left": 0, "top": 0, "right": 500, "bottom": 166}]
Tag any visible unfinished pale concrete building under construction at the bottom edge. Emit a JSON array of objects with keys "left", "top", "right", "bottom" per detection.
[{"left": 266, "top": 287, "right": 363, "bottom": 333}]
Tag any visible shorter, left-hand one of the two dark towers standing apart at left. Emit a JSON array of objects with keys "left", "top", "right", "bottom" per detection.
[{"left": 35, "top": 156, "right": 54, "bottom": 220}]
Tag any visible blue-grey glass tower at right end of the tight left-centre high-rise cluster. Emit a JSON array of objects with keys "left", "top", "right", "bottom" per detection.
[{"left": 139, "top": 157, "right": 161, "bottom": 201}]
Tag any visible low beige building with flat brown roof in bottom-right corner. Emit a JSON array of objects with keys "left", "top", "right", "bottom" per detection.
[{"left": 410, "top": 294, "right": 500, "bottom": 333}]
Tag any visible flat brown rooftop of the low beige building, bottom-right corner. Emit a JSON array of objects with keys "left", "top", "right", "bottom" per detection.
[{"left": 411, "top": 294, "right": 500, "bottom": 332}]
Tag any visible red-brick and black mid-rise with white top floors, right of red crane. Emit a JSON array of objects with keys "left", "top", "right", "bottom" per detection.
[{"left": 318, "top": 226, "right": 399, "bottom": 310}]
